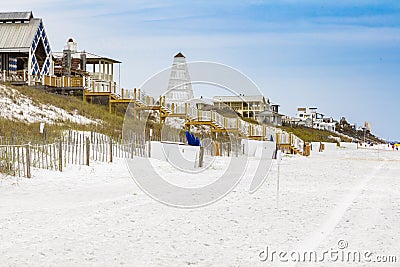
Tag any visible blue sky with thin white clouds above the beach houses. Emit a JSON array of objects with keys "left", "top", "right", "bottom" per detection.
[{"left": 1, "top": 0, "right": 400, "bottom": 140}]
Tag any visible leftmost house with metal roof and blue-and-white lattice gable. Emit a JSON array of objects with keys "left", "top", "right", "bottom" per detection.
[{"left": 0, "top": 12, "right": 53, "bottom": 85}]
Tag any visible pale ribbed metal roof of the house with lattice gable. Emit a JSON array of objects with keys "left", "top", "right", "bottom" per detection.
[{"left": 0, "top": 19, "right": 42, "bottom": 52}]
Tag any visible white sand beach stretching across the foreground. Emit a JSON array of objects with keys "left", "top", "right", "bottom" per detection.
[{"left": 0, "top": 149, "right": 400, "bottom": 266}]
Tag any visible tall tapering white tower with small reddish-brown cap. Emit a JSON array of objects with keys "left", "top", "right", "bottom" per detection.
[{"left": 165, "top": 53, "right": 193, "bottom": 103}]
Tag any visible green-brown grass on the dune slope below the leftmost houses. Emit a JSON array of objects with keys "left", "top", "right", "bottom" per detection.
[{"left": 0, "top": 84, "right": 184, "bottom": 144}]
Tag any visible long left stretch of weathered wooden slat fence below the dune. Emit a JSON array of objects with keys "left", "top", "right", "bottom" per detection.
[{"left": 0, "top": 132, "right": 147, "bottom": 178}]
